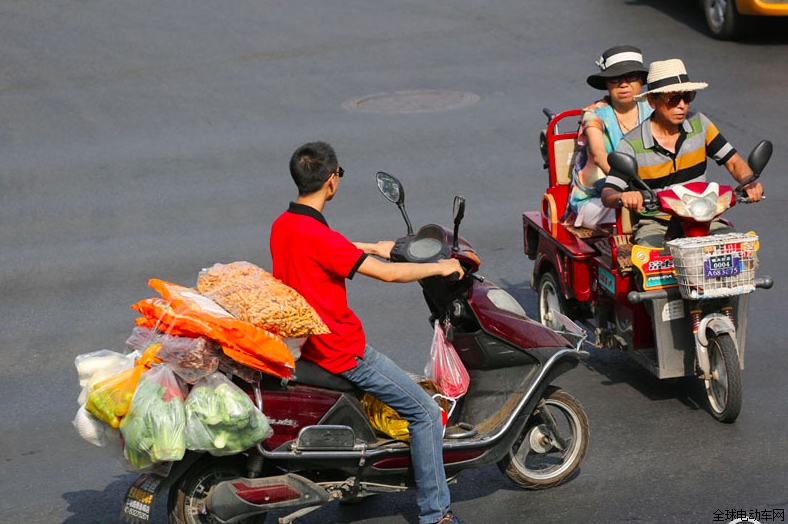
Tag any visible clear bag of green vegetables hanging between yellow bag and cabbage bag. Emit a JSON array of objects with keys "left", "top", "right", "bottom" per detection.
[{"left": 120, "top": 365, "right": 187, "bottom": 469}]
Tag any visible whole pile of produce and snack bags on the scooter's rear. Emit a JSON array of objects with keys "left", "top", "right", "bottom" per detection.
[{"left": 74, "top": 262, "right": 328, "bottom": 470}]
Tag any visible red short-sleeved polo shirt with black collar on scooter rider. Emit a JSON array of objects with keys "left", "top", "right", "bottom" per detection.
[{"left": 271, "top": 203, "right": 367, "bottom": 373}]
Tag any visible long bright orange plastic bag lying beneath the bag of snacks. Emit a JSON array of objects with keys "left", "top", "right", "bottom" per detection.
[{"left": 131, "top": 279, "right": 295, "bottom": 378}]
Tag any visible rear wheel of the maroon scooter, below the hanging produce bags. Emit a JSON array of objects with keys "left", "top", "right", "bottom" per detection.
[{"left": 167, "top": 455, "right": 265, "bottom": 524}]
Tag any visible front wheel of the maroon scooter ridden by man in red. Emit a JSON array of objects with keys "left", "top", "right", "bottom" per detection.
[{"left": 498, "top": 386, "right": 590, "bottom": 489}]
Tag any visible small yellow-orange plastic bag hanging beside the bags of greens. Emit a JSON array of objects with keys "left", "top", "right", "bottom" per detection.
[{"left": 85, "top": 344, "right": 161, "bottom": 429}]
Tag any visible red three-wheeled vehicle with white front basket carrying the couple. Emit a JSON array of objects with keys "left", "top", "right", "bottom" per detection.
[{"left": 523, "top": 110, "right": 773, "bottom": 422}]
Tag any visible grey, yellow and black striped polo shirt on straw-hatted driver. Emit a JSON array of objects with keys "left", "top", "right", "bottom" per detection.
[{"left": 605, "top": 111, "right": 736, "bottom": 191}]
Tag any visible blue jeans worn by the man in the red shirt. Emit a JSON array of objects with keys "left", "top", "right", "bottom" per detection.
[{"left": 340, "top": 346, "right": 451, "bottom": 524}]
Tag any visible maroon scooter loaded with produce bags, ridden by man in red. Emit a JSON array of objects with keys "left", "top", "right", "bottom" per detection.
[{"left": 124, "top": 172, "right": 589, "bottom": 524}]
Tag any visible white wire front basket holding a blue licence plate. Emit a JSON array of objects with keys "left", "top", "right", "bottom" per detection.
[{"left": 666, "top": 233, "right": 758, "bottom": 300}]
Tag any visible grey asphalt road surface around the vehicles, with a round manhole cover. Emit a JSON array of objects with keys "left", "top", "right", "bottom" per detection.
[{"left": 0, "top": 0, "right": 788, "bottom": 524}]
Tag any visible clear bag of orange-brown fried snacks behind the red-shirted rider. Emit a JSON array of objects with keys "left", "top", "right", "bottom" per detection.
[{"left": 197, "top": 262, "right": 329, "bottom": 338}]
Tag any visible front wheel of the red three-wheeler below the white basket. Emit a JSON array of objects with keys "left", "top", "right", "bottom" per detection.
[{"left": 704, "top": 333, "right": 742, "bottom": 422}]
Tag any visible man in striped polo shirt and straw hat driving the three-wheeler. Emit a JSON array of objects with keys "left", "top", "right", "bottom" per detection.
[{"left": 602, "top": 59, "right": 763, "bottom": 247}]
